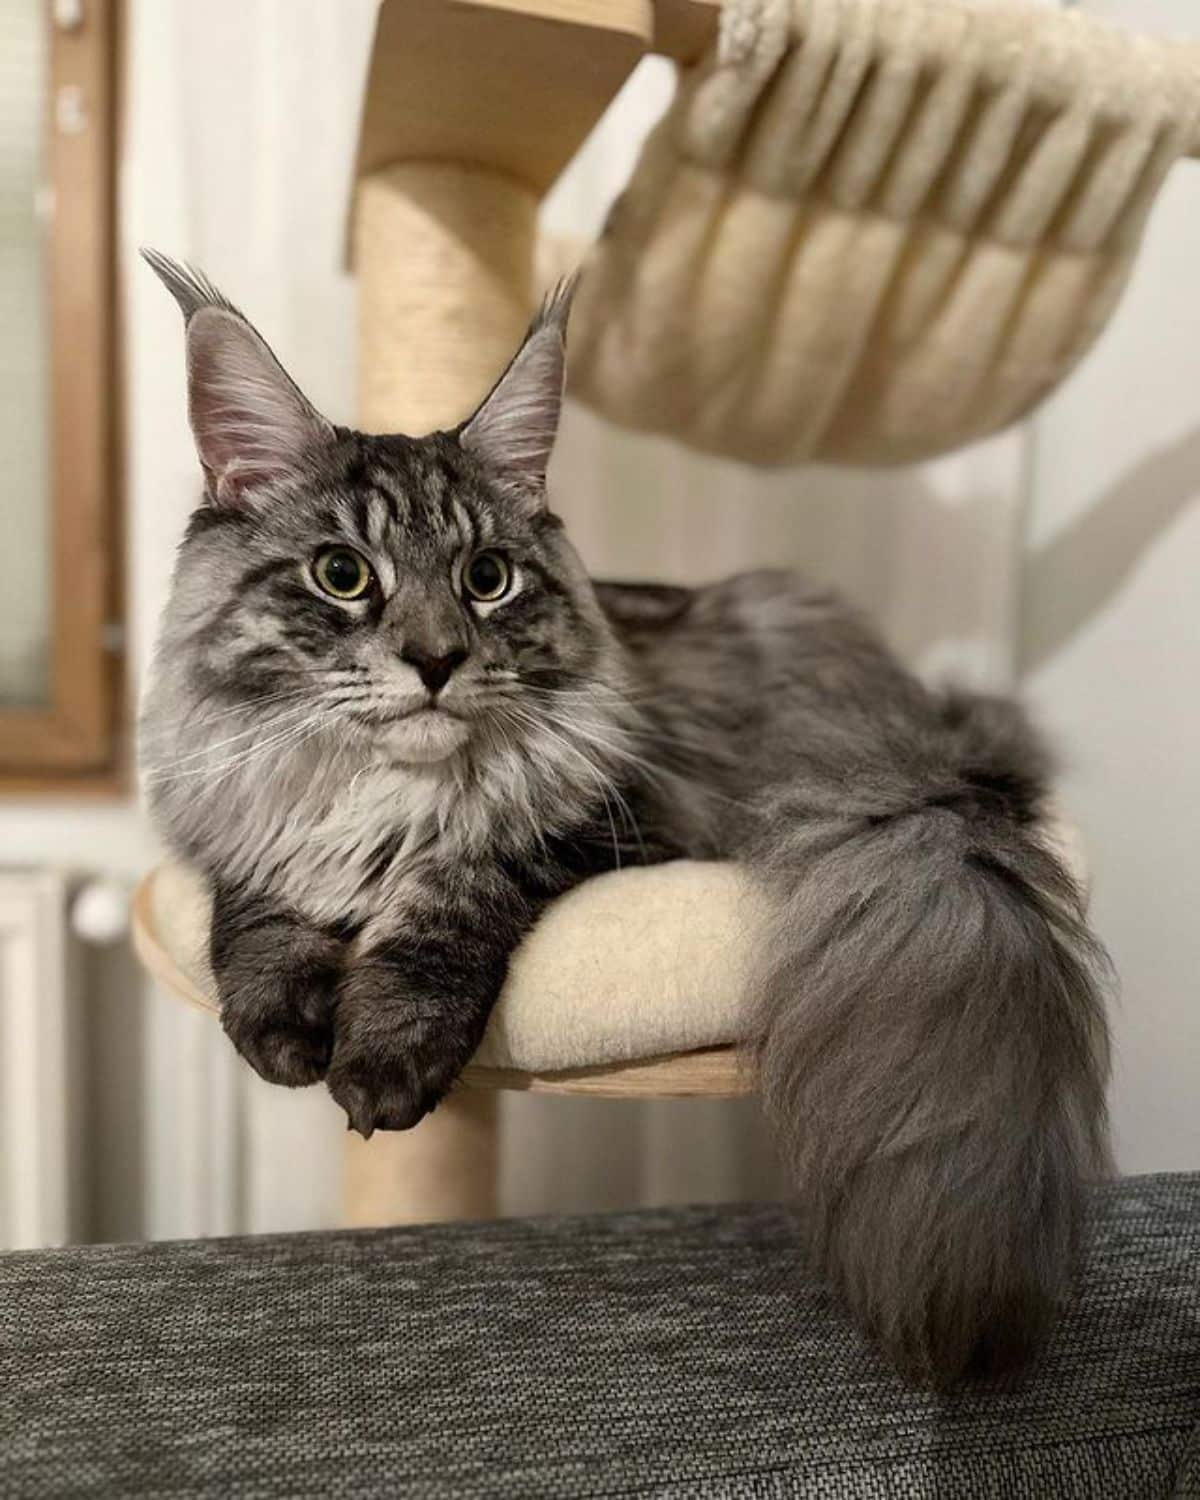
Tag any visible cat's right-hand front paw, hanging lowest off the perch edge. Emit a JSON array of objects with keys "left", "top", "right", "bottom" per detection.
[{"left": 326, "top": 969, "right": 479, "bottom": 1140}]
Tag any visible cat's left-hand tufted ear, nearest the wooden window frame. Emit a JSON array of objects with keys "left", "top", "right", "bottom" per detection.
[{"left": 143, "top": 251, "right": 335, "bottom": 506}]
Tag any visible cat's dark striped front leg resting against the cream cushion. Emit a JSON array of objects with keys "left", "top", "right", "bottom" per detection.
[{"left": 326, "top": 870, "right": 533, "bottom": 1136}]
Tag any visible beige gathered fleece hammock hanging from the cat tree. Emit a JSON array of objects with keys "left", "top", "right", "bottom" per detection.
[{"left": 572, "top": 0, "right": 1200, "bottom": 464}]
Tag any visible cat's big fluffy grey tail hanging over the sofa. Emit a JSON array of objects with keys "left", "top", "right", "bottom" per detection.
[{"left": 758, "top": 698, "right": 1109, "bottom": 1386}]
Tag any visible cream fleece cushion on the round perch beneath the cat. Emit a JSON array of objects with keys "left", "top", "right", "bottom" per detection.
[{"left": 150, "top": 819, "right": 1086, "bottom": 1073}]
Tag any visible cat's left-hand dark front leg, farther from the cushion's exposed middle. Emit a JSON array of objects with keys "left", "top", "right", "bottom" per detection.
[{"left": 210, "top": 887, "right": 347, "bottom": 1088}]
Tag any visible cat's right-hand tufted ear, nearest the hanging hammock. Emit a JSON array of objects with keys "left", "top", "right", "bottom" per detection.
[{"left": 459, "top": 278, "right": 576, "bottom": 504}]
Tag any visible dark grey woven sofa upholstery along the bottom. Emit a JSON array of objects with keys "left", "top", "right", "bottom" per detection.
[{"left": 0, "top": 1176, "right": 1200, "bottom": 1500}]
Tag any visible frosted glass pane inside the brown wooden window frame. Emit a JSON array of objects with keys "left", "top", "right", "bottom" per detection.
[{"left": 0, "top": 0, "right": 51, "bottom": 707}]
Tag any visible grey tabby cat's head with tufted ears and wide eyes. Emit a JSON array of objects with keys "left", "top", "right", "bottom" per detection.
[{"left": 147, "top": 254, "right": 612, "bottom": 786}]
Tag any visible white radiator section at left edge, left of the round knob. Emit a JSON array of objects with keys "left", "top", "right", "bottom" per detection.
[{"left": 0, "top": 870, "right": 80, "bottom": 1250}]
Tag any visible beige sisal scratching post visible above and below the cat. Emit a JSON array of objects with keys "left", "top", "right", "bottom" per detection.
[{"left": 345, "top": 162, "right": 537, "bottom": 1226}]
